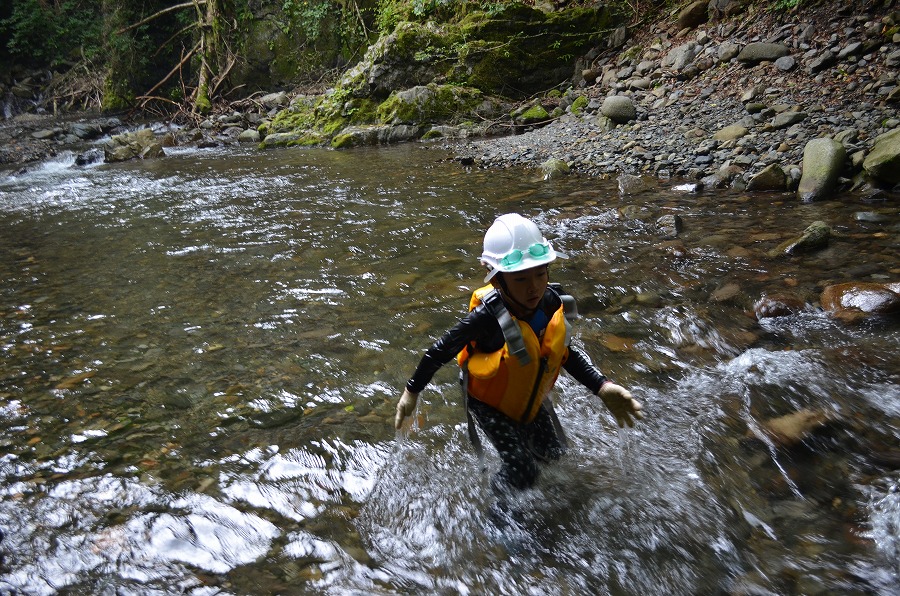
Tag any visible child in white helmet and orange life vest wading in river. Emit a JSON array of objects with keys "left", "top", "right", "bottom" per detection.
[{"left": 394, "top": 213, "right": 643, "bottom": 495}]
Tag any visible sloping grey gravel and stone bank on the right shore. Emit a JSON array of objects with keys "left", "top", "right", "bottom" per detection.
[{"left": 452, "top": 2, "right": 900, "bottom": 195}]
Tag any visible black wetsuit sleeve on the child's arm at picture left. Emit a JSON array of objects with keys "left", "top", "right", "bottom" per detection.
[{"left": 406, "top": 306, "right": 504, "bottom": 393}]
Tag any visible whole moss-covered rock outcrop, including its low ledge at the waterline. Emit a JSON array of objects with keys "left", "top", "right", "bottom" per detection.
[{"left": 263, "top": 4, "right": 624, "bottom": 147}]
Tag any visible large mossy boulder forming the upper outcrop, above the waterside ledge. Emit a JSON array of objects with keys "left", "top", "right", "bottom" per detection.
[{"left": 338, "top": 4, "right": 616, "bottom": 100}]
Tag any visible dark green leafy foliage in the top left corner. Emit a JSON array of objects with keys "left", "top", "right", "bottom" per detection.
[{"left": 0, "top": 0, "right": 103, "bottom": 66}]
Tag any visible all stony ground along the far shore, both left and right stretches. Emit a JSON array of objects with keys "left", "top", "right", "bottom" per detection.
[{"left": 0, "top": 0, "right": 900, "bottom": 197}]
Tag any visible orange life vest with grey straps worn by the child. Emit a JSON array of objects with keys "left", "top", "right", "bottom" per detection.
[{"left": 456, "top": 285, "right": 569, "bottom": 423}]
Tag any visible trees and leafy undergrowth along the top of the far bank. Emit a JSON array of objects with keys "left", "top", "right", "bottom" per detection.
[{"left": 0, "top": 0, "right": 676, "bottom": 117}]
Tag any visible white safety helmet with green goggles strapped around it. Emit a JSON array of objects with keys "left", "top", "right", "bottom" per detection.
[{"left": 481, "top": 213, "right": 568, "bottom": 282}]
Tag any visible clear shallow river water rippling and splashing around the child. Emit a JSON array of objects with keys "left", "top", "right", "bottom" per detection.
[{"left": 0, "top": 144, "right": 900, "bottom": 594}]
